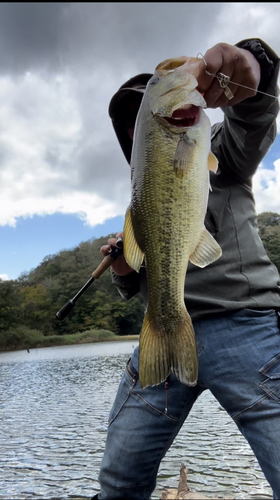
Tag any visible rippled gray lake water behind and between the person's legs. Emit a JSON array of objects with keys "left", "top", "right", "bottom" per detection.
[{"left": 0, "top": 341, "right": 272, "bottom": 500}]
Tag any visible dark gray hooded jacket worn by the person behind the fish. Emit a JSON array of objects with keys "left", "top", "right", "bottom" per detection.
[{"left": 109, "top": 38, "right": 280, "bottom": 320}]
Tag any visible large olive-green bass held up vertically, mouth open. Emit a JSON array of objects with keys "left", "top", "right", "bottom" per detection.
[{"left": 124, "top": 56, "right": 222, "bottom": 387}]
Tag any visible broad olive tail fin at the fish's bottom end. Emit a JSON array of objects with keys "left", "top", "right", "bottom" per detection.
[{"left": 139, "top": 310, "right": 198, "bottom": 388}]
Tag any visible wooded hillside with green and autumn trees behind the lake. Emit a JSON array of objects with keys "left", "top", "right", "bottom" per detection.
[{"left": 0, "top": 212, "right": 280, "bottom": 346}]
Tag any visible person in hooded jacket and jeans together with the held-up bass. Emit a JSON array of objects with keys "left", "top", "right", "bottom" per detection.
[{"left": 93, "top": 39, "right": 280, "bottom": 500}]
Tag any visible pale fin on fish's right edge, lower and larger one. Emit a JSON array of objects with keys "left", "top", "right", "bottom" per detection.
[{"left": 189, "top": 228, "right": 222, "bottom": 267}]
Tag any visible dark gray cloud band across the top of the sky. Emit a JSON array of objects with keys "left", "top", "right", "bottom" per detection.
[{"left": 0, "top": 2, "right": 221, "bottom": 73}]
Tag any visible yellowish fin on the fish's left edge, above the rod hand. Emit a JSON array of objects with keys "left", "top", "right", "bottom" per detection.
[{"left": 123, "top": 207, "right": 144, "bottom": 273}]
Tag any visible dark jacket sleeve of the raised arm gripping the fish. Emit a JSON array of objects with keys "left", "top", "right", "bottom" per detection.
[{"left": 212, "top": 42, "right": 279, "bottom": 183}]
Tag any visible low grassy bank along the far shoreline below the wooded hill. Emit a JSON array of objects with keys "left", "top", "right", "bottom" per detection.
[{"left": 0, "top": 327, "right": 139, "bottom": 351}]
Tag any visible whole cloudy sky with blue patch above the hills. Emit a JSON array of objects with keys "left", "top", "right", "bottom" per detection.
[{"left": 0, "top": 2, "right": 280, "bottom": 279}]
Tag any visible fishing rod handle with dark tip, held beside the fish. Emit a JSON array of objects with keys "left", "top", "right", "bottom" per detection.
[{"left": 56, "top": 238, "right": 123, "bottom": 321}]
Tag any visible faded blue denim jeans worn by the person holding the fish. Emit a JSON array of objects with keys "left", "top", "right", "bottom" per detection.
[{"left": 98, "top": 309, "right": 280, "bottom": 500}]
